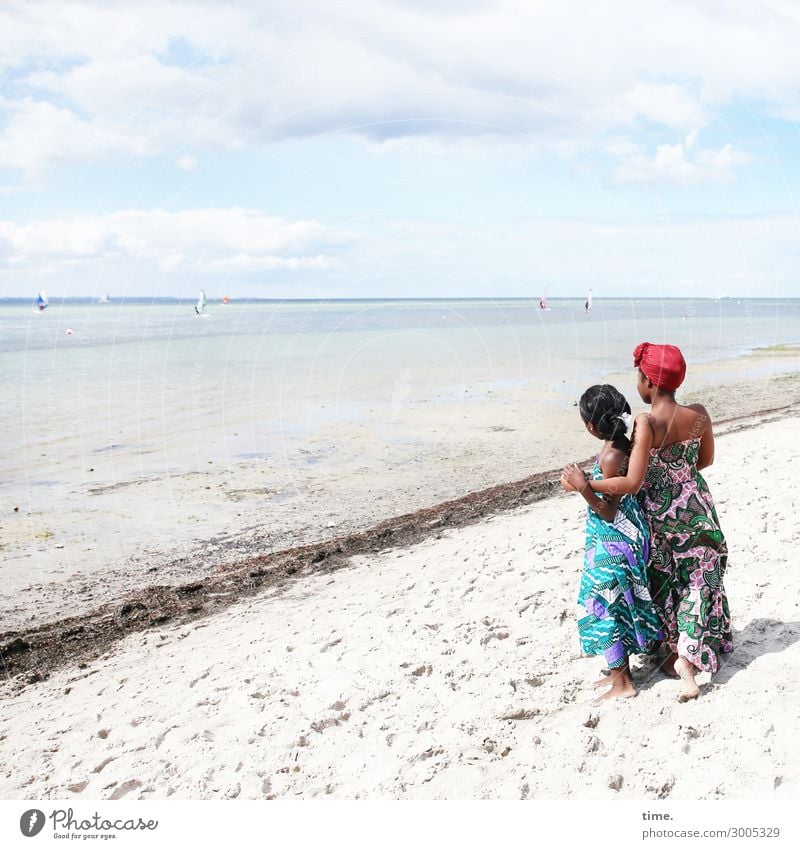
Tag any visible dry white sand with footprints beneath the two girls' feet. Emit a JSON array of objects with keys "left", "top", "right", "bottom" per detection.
[{"left": 0, "top": 418, "right": 800, "bottom": 799}]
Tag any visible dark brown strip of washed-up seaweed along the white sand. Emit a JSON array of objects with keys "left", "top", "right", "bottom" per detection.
[{"left": 0, "top": 401, "right": 800, "bottom": 695}]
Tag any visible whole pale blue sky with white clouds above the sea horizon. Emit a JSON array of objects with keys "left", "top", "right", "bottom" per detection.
[{"left": 0, "top": 0, "right": 800, "bottom": 298}]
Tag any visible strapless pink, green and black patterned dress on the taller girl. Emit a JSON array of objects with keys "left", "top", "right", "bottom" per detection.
[{"left": 639, "top": 438, "right": 733, "bottom": 673}]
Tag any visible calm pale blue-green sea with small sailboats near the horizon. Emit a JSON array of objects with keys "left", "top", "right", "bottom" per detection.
[{"left": 0, "top": 298, "right": 800, "bottom": 491}]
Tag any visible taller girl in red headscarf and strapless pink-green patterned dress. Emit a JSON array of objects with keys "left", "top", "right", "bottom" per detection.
[{"left": 563, "top": 342, "right": 733, "bottom": 702}]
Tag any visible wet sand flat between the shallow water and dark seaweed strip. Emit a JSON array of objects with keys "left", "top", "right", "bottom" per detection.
[{"left": 0, "top": 347, "right": 800, "bottom": 633}]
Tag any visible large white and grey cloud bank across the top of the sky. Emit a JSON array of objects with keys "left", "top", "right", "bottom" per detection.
[{"left": 0, "top": 0, "right": 800, "bottom": 180}]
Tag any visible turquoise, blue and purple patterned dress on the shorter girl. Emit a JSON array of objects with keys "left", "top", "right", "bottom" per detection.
[{"left": 578, "top": 464, "right": 661, "bottom": 669}]
